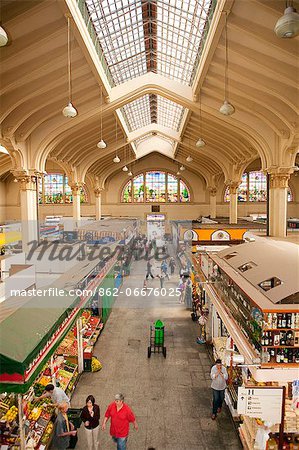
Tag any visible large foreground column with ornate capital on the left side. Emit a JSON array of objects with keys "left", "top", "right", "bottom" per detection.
[{"left": 14, "top": 172, "right": 38, "bottom": 252}]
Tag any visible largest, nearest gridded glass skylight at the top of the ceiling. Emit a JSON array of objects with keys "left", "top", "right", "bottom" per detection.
[{"left": 85, "top": 0, "right": 215, "bottom": 86}]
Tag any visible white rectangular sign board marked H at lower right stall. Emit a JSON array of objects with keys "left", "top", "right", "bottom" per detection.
[{"left": 237, "top": 387, "right": 283, "bottom": 424}]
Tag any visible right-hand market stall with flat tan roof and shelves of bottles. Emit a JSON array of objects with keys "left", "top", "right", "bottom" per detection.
[{"left": 192, "top": 242, "right": 299, "bottom": 450}]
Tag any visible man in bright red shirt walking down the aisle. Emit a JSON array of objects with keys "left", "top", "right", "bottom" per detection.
[{"left": 102, "top": 394, "right": 138, "bottom": 450}]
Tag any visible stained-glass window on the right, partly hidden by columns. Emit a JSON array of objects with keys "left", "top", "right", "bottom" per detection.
[{"left": 224, "top": 171, "right": 293, "bottom": 202}]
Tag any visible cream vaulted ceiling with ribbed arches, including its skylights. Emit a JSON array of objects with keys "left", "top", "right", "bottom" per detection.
[{"left": 0, "top": 0, "right": 299, "bottom": 188}]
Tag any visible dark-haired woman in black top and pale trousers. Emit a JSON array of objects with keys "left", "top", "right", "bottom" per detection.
[{"left": 81, "top": 395, "right": 100, "bottom": 450}]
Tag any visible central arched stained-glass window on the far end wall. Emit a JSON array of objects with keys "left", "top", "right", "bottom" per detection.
[{"left": 121, "top": 170, "right": 191, "bottom": 203}]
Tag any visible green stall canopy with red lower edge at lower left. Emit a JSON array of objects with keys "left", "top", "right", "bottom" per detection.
[{"left": 0, "top": 291, "right": 80, "bottom": 390}]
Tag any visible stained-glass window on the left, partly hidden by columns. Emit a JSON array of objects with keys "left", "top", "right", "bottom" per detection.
[{"left": 39, "top": 173, "right": 88, "bottom": 204}]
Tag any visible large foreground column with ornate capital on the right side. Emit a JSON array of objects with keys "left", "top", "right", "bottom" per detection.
[{"left": 268, "top": 169, "right": 290, "bottom": 237}]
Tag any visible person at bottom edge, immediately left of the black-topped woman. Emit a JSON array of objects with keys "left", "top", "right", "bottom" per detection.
[{"left": 52, "top": 402, "right": 77, "bottom": 450}]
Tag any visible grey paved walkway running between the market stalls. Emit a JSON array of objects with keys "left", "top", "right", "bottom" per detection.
[{"left": 72, "top": 255, "right": 242, "bottom": 450}]
